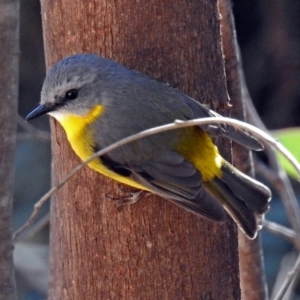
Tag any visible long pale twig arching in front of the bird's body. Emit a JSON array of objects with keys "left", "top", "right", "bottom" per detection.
[{"left": 14, "top": 117, "right": 300, "bottom": 239}]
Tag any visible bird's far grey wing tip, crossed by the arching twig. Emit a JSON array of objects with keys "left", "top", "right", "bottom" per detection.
[{"left": 179, "top": 95, "right": 264, "bottom": 151}]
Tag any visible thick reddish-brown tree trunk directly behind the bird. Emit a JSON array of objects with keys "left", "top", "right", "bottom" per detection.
[{"left": 42, "top": 0, "right": 240, "bottom": 300}]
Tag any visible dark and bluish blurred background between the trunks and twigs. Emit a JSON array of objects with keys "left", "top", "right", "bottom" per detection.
[{"left": 14, "top": 0, "right": 300, "bottom": 300}]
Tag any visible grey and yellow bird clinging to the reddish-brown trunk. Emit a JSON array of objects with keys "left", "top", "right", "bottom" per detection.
[{"left": 26, "top": 54, "right": 271, "bottom": 238}]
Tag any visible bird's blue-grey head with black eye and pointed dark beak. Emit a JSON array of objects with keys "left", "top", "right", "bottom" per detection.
[{"left": 26, "top": 54, "right": 105, "bottom": 120}]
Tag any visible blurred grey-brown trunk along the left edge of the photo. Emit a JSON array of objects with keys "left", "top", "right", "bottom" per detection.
[{"left": 0, "top": 0, "right": 19, "bottom": 300}]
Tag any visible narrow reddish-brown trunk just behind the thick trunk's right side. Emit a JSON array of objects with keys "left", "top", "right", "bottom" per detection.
[{"left": 219, "top": 0, "right": 267, "bottom": 300}]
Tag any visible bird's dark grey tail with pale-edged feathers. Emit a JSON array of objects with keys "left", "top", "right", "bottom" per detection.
[{"left": 204, "top": 161, "right": 272, "bottom": 238}]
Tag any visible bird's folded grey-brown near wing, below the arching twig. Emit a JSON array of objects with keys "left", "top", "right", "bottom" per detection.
[{"left": 130, "top": 151, "right": 224, "bottom": 221}]
